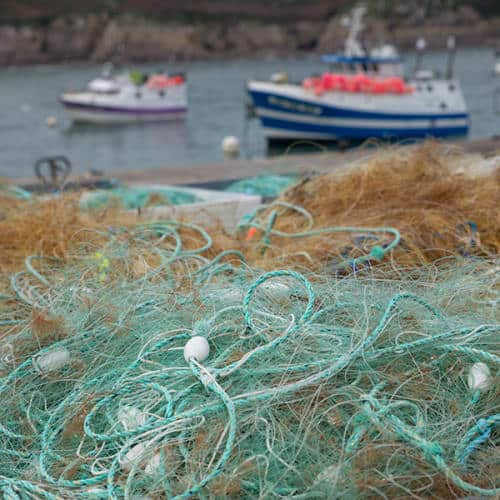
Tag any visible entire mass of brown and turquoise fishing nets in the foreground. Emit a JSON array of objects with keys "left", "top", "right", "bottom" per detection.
[{"left": 0, "top": 147, "right": 500, "bottom": 500}]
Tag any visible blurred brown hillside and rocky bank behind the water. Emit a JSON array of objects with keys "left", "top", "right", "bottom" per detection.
[{"left": 0, "top": 0, "right": 500, "bottom": 65}]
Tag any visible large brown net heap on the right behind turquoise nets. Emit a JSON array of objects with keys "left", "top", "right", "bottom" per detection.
[{"left": 235, "top": 144, "right": 500, "bottom": 268}]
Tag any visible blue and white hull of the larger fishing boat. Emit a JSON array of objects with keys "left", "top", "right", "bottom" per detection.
[{"left": 248, "top": 82, "right": 469, "bottom": 141}]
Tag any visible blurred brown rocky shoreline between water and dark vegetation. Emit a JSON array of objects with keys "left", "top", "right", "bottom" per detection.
[{"left": 0, "top": 10, "right": 500, "bottom": 66}]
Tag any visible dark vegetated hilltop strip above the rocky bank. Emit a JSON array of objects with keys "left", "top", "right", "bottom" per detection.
[{"left": 0, "top": 0, "right": 500, "bottom": 23}]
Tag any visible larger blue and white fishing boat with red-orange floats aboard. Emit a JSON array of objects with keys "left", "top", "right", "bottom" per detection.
[{"left": 247, "top": 6, "right": 469, "bottom": 142}]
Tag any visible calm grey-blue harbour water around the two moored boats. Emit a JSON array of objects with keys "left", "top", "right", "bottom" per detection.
[{"left": 0, "top": 49, "right": 500, "bottom": 177}]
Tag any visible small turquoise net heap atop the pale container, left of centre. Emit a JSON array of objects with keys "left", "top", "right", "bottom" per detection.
[{"left": 81, "top": 186, "right": 201, "bottom": 210}]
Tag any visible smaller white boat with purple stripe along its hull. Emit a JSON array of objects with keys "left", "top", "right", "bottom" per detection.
[{"left": 60, "top": 67, "right": 187, "bottom": 123}]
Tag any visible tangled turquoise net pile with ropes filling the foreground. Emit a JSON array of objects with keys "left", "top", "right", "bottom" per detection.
[{"left": 0, "top": 214, "right": 500, "bottom": 499}]
